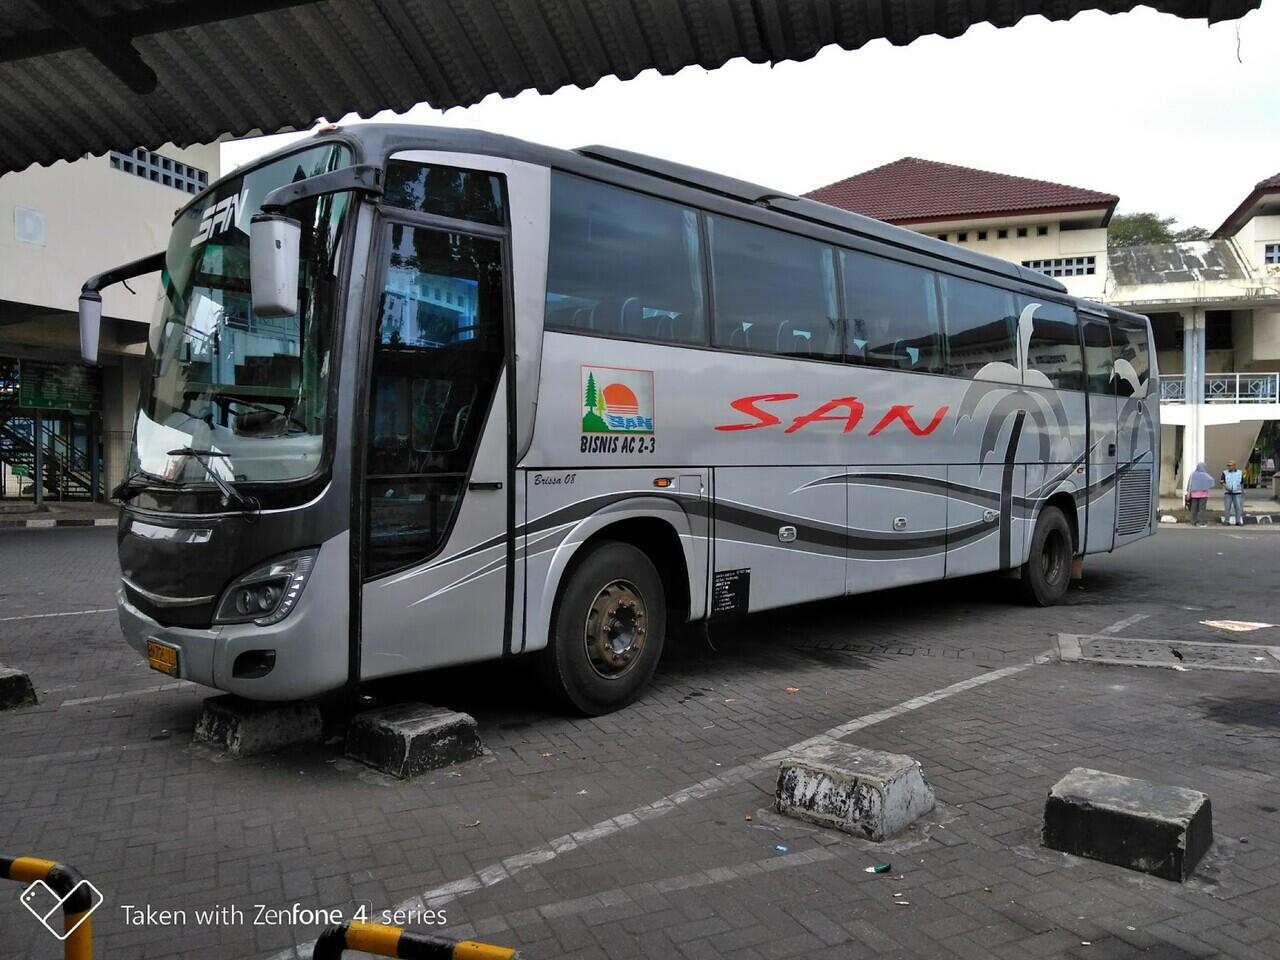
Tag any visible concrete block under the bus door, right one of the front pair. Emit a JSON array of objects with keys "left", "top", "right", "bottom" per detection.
[{"left": 347, "top": 703, "right": 483, "bottom": 780}]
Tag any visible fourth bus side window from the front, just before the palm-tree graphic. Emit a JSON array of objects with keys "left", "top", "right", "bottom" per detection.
[{"left": 942, "top": 275, "right": 1021, "bottom": 380}]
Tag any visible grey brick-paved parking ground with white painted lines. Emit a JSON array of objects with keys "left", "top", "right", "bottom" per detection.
[{"left": 0, "top": 529, "right": 1280, "bottom": 960}]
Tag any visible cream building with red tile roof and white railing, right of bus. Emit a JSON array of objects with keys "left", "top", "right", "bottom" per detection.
[{"left": 806, "top": 157, "right": 1280, "bottom": 495}]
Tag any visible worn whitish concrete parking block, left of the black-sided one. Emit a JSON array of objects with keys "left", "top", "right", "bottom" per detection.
[{"left": 773, "top": 742, "right": 934, "bottom": 841}]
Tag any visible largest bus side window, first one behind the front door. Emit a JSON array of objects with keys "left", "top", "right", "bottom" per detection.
[{"left": 547, "top": 173, "right": 707, "bottom": 343}]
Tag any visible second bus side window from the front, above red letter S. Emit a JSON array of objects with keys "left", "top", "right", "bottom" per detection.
[{"left": 707, "top": 216, "right": 840, "bottom": 360}]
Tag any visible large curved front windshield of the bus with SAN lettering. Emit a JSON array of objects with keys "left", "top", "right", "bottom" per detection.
[{"left": 131, "top": 143, "right": 351, "bottom": 485}]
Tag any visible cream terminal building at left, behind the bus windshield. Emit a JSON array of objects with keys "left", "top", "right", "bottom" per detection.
[{"left": 0, "top": 145, "right": 219, "bottom": 503}]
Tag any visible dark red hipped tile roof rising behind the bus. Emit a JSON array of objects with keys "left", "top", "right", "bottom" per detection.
[{"left": 805, "top": 156, "right": 1120, "bottom": 224}]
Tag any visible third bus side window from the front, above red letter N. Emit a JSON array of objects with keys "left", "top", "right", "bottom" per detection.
[{"left": 840, "top": 250, "right": 942, "bottom": 372}]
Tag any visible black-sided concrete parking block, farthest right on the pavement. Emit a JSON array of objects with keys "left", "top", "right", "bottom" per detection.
[{"left": 1043, "top": 767, "right": 1213, "bottom": 882}]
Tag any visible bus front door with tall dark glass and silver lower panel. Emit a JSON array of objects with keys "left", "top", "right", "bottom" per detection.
[{"left": 360, "top": 223, "right": 518, "bottom": 678}]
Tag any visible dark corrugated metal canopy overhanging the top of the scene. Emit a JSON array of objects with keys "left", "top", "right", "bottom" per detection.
[{"left": 0, "top": 0, "right": 1261, "bottom": 173}]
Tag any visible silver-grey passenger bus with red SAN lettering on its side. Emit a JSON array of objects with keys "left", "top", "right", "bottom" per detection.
[{"left": 81, "top": 124, "right": 1160, "bottom": 714}]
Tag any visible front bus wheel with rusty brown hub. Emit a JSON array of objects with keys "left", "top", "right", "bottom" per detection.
[{"left": 541, "top": 540, "right": 667, "bottom": 717}]
